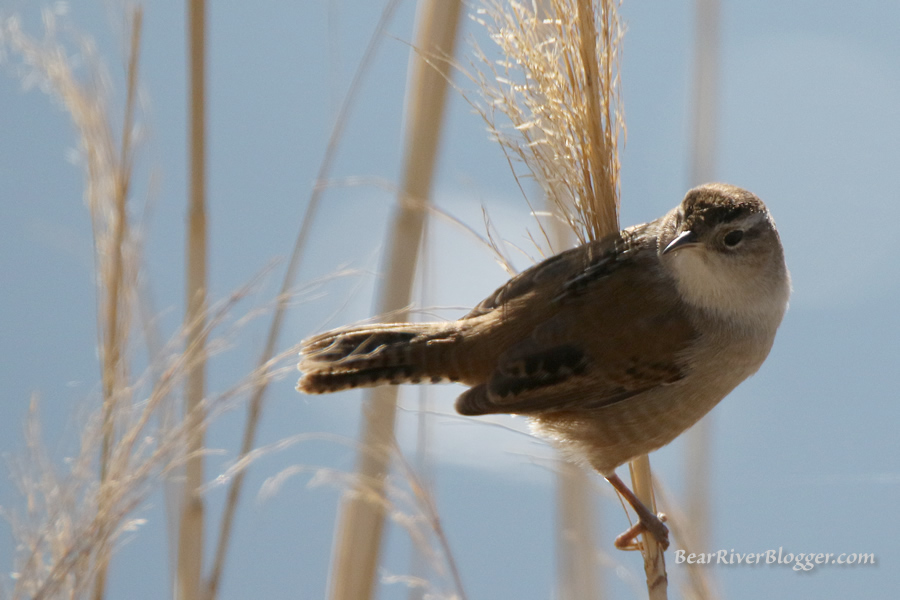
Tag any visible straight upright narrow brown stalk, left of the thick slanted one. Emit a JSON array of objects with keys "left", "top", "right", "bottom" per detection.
[{"left": 177, "top": 0, "right": 207, "bottom": 600}]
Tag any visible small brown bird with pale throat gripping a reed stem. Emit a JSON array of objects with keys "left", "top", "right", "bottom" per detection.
[{"left": 297, "top": 183, "right": 791, "bottom": 549}]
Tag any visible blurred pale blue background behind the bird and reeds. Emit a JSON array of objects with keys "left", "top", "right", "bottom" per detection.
[{"left": 0, "top": 0, "right": 900, "bottom": 599}]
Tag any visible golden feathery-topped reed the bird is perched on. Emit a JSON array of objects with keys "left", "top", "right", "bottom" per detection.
[{"left": 470, "top": 0, "right": 667, "bottom": 599}]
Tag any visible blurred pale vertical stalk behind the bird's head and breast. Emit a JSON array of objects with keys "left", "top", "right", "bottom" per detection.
[{"left": 685, "top": 0, "right": 719, "bottom": 599}]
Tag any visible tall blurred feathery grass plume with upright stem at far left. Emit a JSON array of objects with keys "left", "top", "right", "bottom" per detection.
[{"left": 0, "top": 8, "right": 142, "bottom": 599}]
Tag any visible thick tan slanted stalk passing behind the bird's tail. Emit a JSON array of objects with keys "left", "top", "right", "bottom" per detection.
[{"left": 330, "top": 0, "right": 462, "bottom": 600}]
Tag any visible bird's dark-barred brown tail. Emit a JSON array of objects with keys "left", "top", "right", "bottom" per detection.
[{"left": 297, "top": 322, "right": 459, "bottom": 394}]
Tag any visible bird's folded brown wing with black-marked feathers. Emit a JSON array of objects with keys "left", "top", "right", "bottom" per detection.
[{"left": 457, "top": 232, "right": 697, "bottom": 415}]
